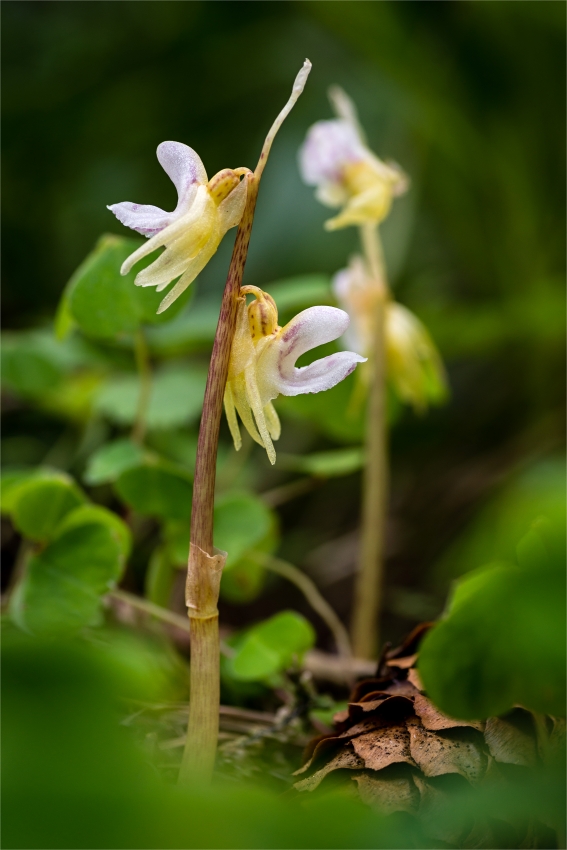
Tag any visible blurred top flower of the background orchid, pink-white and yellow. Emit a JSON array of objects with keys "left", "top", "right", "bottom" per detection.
[{"left": 299, "top": 87, "right": 409, "bottom": 230}]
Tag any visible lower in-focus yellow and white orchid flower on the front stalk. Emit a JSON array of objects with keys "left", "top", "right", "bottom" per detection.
[{"left": 224, "top": 286, "right": 365, "bottom": 464}]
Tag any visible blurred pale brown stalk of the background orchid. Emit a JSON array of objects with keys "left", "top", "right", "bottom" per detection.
[{"left": 351, "top": 224, "right": 388, "bottom": 658}]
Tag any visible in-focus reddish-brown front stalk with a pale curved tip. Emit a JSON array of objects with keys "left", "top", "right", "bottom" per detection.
[{"left": 179, "top": 60, "right": 311, "bottom": 784}]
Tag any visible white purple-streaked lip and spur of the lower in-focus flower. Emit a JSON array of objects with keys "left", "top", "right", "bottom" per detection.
[{"left": 257, "top": 307, "right": 365, "bottom": 404}]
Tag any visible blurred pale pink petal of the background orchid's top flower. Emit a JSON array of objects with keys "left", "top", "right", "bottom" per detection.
[{"left": 299, "top": 119, "right": 367, "bottom": 186}]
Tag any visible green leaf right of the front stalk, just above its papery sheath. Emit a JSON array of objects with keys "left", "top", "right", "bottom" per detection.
[{"left": 214, "top": 493, "right": 274, "bottom": 573}]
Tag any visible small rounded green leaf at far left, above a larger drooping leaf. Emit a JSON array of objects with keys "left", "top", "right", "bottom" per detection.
[{"left": 9, "top": 470, "right": 85, "bottom": 540}]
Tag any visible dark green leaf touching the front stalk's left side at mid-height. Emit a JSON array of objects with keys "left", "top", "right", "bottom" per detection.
[{"left": 114, "top": 457, "right": 193, "bottom": 519}]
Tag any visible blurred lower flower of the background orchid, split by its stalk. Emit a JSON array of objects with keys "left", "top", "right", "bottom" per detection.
[{"left": 333, "top": 256, "right": 447, "bottom": 412}]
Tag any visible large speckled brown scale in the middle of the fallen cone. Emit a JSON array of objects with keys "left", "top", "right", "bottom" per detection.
[{"left": 407, "top": 717, "right": 486, "bottom": 782}]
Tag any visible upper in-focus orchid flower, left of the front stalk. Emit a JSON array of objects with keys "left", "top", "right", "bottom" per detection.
[{"left": 108, "top": 142, "right": 249, "bottom": 313}]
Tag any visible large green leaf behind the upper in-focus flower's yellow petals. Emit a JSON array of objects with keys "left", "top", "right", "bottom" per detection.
[{"left": 63, "top": 235, "right": 191, "bottom": 339}]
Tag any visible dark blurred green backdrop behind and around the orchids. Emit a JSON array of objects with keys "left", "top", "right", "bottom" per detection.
[{"left": 2, "top": 0, "right": 565, "bottom": 634}]
